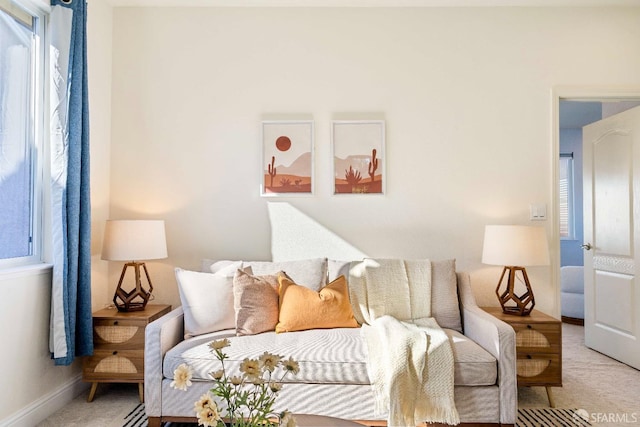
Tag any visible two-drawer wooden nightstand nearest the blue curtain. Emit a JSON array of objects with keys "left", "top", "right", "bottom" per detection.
[{"left": 82, "top": 304, "right": 171, "bottom": 402}]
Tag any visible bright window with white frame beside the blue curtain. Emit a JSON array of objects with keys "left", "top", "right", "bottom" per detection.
[{"left": 0, "top": 0, "right": 45, "bottom": 267}]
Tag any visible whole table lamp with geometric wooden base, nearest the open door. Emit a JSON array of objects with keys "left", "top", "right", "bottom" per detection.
[{"left": 482, "top": 225, "right": 549, "bottom": 316}]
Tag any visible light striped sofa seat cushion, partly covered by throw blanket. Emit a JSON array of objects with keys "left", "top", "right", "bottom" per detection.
[{"left": 163, "top": 328, "right": 498, "bottom": 386}]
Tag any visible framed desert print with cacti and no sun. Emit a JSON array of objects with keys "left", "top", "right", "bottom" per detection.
[{"left": 331, "top": 120, "right": 386, "bottom": 194}]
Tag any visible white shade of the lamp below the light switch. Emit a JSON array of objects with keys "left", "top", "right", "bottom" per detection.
[{"left": 482, "top": 225, "right": 549, "bottom": 267}]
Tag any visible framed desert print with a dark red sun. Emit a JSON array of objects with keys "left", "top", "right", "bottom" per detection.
[{"left": 261, "top": 120, "right": 313, "bottom": 197}]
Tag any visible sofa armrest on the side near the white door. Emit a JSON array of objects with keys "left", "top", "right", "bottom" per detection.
[{"left": 458, "top": 273, "right": 518, "bottom": 424}]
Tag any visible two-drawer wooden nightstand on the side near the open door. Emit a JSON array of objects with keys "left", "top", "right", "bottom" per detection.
[{"left": 482, "top": 307, "right": 562, "bottom": 408}]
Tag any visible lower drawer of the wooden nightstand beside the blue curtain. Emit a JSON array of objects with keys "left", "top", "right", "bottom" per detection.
[{"left": 82, "top": 350, "right": 144, "bottom": 382}]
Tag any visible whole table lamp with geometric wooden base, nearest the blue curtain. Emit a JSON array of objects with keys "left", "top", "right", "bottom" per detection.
[{"left": 102, "top": 220, "right": 167, "bottom": 311}]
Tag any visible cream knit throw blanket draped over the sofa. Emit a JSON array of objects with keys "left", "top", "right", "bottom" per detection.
[{"left": 349, "top": 259, "right": 460, "bottom": 427}]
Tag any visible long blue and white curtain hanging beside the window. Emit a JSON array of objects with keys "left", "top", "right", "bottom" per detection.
[{"left": 50, "top": 0, "right": 93, "bottom": 365}]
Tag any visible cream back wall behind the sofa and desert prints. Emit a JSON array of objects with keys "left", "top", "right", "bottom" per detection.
[{"left": 108, "top": 8, "right": 640, "bottom": 315}]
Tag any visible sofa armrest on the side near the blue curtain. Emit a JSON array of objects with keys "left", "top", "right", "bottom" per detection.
[{"left": 144, "top": 307, "right": 184, "bottom": 417}]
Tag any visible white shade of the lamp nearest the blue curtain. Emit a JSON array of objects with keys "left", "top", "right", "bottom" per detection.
[{"left": 102, "top": 220, "right": 167, "bottom": 261}]
